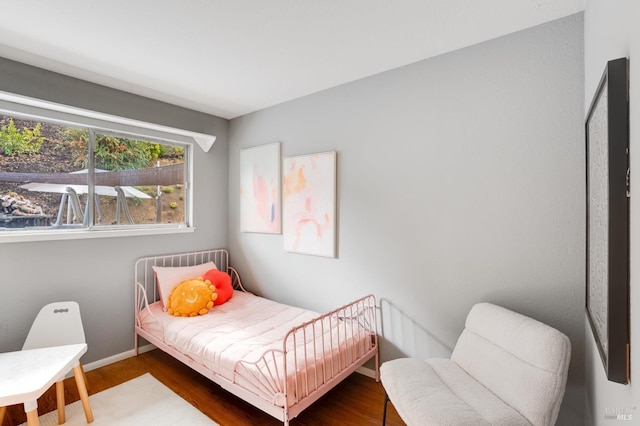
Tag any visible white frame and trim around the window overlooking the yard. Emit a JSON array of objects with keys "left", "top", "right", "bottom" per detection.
[{"left": 0, "top": 91, "right": 216, "bottom": 244}]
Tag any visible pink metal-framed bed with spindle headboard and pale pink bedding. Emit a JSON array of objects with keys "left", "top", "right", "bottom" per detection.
[{"left": 135, "top": 249, "right": 379, "bottom": 425}]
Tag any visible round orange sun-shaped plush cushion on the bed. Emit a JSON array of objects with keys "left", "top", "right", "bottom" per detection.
[{"left": 167, "top": 278, "right": 218, "bottom": 317}]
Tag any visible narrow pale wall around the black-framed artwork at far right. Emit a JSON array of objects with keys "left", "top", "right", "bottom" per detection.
[{"left": 584, "top": 0, "right": 640, "bottom": 425}]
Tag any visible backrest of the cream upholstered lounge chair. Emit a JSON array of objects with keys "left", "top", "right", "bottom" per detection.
[{"left": 451, "top": 303, "right": 571, "bottom": 426}]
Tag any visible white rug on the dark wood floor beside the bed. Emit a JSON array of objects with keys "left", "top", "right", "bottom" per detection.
[{"left": 23, "top": 373, "right": 217, "bottom": 426}]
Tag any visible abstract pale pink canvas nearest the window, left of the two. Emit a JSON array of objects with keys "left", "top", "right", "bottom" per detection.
[{"left": 240, "top": 142, "right": 281, "bottom": 234}]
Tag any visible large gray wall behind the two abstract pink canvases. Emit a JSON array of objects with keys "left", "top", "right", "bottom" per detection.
[{"left": 229, "top": 14, "right": 585, "bottom": 424}]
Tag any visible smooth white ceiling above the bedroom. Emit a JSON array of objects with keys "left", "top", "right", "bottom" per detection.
[{"left": 0, "top": 0, "right": 585, "bottom": 118}]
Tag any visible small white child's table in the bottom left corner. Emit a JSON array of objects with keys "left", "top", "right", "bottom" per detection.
[{"left": 0, "top": 343, "right": 93, "bottom": 426}]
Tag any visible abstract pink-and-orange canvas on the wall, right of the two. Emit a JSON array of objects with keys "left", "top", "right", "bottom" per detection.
[{"left": 282, "top": 151, "right": 337, "bottom": 257}]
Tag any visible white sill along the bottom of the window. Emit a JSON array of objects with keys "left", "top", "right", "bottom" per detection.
[{"left": 0, "top": 226, "right": 195, "bottom": 244}]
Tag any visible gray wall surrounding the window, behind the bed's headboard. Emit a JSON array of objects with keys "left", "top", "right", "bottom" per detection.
[{"left": 0, "top": 58, "right": 229, "bottom": 364}]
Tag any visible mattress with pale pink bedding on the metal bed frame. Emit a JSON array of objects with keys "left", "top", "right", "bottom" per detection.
[{"left": 140, "top": 291, "right": 372, "bottom": 406}]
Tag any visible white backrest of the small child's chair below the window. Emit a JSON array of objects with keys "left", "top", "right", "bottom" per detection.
[{"left": 22, "top": 302, "right": 86, "bottom": 350}]
